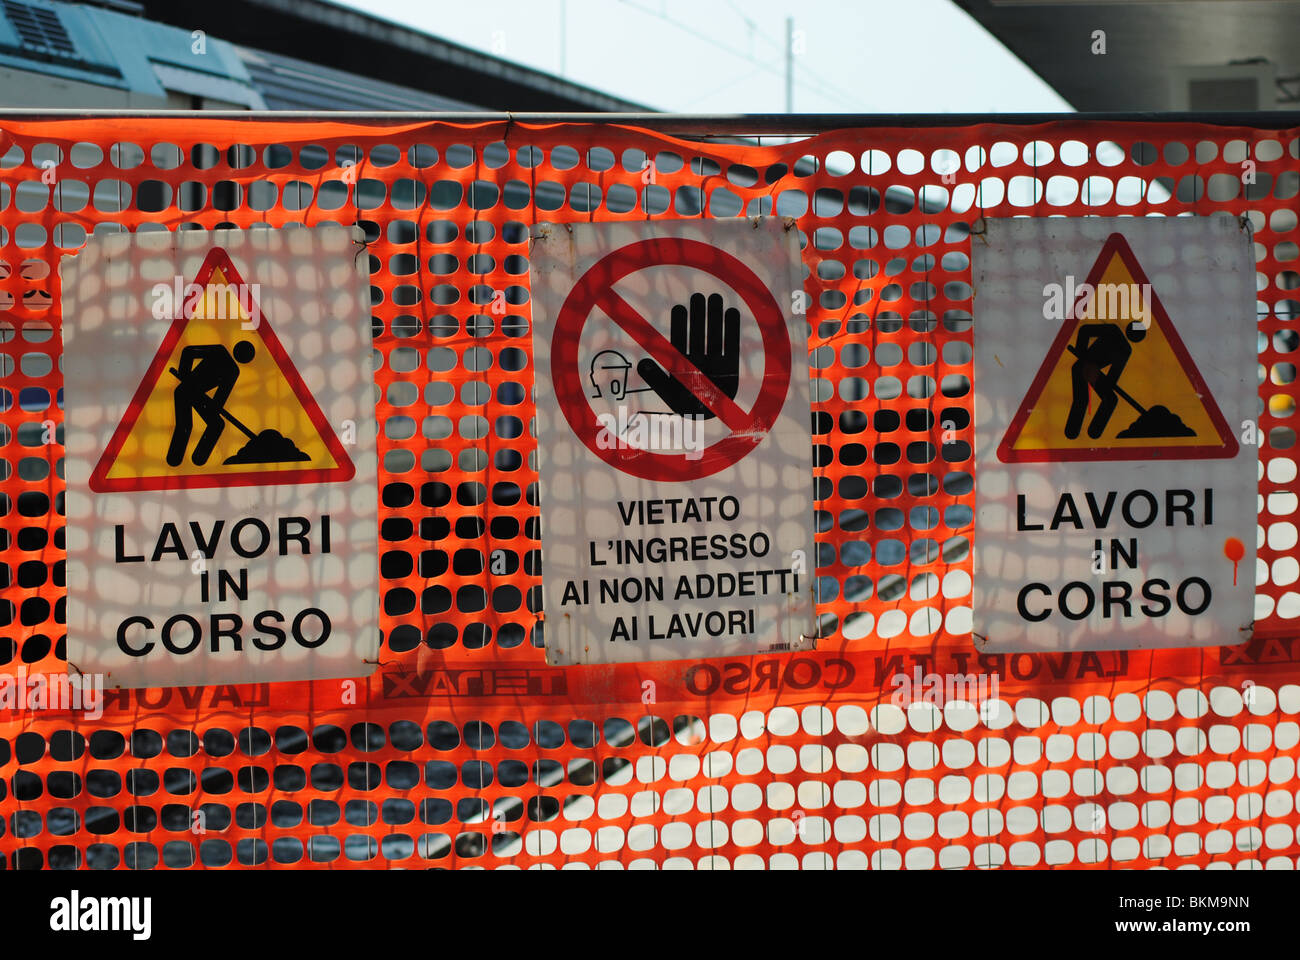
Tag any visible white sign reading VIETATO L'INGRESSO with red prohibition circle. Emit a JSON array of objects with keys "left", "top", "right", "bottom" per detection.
[{"left": 529, "top": 219, "right": 816, "bottom": 663}]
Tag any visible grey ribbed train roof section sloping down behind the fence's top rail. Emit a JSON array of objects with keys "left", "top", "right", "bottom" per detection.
[{"left": 235, "top": 47, "right": 482, "bottom": 111}]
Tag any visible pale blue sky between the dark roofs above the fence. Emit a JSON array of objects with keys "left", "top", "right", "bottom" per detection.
[{"left": 334, "top": 0, "right": 1071, "bottom": 113}]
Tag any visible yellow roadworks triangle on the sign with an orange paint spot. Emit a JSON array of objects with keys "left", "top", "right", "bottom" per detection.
[{"left": 997, "top": 233, "right": 1238, "bottom": 463}]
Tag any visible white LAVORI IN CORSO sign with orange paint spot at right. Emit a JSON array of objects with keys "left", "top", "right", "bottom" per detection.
[{"left": 971, "top": 217, "right": 1260, "bottom": 652}]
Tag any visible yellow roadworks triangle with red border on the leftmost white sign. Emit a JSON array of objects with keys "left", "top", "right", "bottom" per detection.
[{"left": 90, "top": 247, "right": 355, "bottom": 493}]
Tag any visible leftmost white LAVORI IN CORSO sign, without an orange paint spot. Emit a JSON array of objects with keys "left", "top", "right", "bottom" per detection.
[{"left": 61, "top": 226, "right": 380, "bottom": 687}]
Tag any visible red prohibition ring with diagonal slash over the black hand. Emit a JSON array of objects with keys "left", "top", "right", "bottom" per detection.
[{"left": 551, "top": 237, "right": 790, "bottom": 481}]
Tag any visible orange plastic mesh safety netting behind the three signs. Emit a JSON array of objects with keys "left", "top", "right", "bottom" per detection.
[{"left": 0, "top": 117, "right": 1300, "bottom": 869}]
